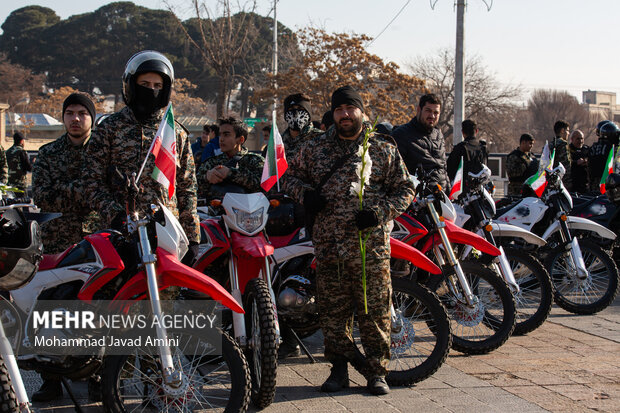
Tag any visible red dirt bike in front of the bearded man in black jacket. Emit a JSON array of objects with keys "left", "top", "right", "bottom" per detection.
[{"left": 392, "top": 174, "right": 516, "bottom": 354}]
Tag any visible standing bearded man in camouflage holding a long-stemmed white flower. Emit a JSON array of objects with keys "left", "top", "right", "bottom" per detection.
[{"left": 283, "top": 86, "right": 414, "bottom": 394}]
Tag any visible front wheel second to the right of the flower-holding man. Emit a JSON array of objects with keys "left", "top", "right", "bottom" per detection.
[{"left": 427, "top": 261, "right": 516, "bottom": 354}]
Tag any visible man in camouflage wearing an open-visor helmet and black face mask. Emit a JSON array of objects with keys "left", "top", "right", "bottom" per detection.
[{"left": 84, "top": 51, "right": 200, "bottom": 244}]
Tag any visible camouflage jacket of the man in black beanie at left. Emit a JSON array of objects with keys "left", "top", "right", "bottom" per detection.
[{"left": 32, "top": 134, "right": 100, "bottom": 254}]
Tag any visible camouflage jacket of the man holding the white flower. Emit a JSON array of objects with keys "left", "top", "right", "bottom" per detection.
[{"left": 282, "top": 124, "right": 415, "bottom": 260}]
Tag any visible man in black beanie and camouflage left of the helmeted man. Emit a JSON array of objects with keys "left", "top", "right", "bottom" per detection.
[{"left": 32, "top": 93, "right": 99, "bottom": 254}]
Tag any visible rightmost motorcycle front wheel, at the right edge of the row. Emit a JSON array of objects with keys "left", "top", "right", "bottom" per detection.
[{"left": 545, "top": 239, "right": 618, "bottom": 314}]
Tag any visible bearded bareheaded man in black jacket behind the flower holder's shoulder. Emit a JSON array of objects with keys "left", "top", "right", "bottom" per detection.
[{"left": 392, "top": 93, "right": 450, "bottom": 190}]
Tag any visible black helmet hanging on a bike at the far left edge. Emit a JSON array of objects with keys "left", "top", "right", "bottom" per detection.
[{"left": 0, "top": 209, "right": 43, "bottom": 291}]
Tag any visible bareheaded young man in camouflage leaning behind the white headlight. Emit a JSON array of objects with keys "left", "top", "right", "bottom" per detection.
[{"left": 197, "top": 117, "right": 265, "bottom": 200}]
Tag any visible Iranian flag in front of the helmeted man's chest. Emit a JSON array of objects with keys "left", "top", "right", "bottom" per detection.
[{"left": 150, "top": 103, "right": 178, "bottom": 199}]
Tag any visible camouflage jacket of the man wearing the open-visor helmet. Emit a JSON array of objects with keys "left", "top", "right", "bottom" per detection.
[{"left": 83, "top": 107, "right": 200, "bottom": 242}]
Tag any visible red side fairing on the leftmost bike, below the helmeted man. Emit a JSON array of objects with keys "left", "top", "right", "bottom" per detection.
[{"left": 78, "top": 232, "right": 125, "bottom": 302}]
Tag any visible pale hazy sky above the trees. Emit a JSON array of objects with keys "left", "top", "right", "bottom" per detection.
[{"left": 0, "top": 0, "right": 620, "bottom": 102}]
